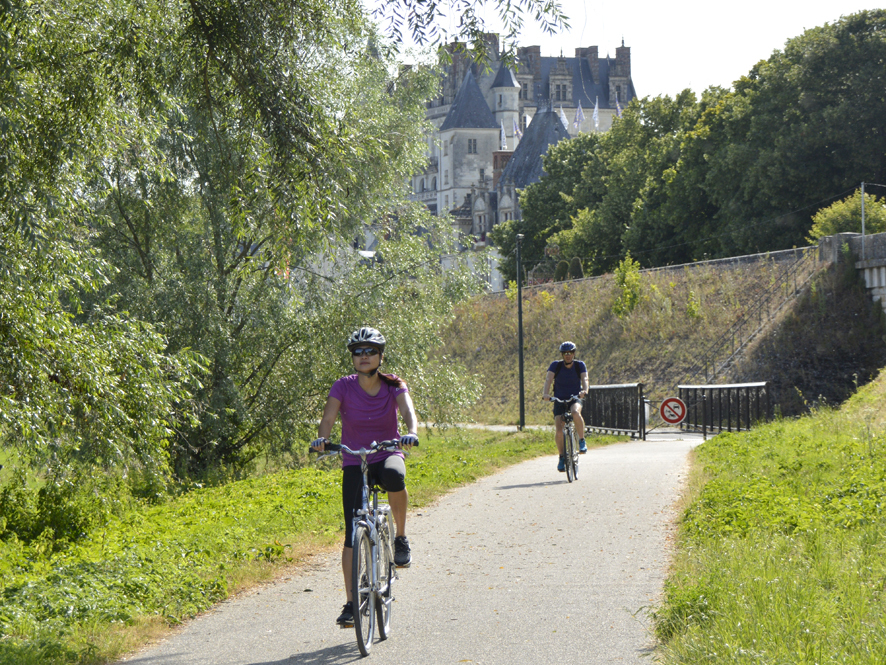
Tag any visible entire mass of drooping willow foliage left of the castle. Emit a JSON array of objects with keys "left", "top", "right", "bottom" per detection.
[{"left": 0, "top": 0, "right": 558, "bottom": 474}]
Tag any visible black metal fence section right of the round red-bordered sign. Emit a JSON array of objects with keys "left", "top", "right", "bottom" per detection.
[{"left": 677, "top": 381, "right": 772, "bottom": 436}]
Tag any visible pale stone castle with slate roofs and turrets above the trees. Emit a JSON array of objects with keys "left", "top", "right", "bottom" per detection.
[{"left": 411, "top": 34, "right": 636, "bottom": 290}]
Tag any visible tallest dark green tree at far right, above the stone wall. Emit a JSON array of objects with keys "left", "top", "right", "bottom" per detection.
[{"left": 699, "top": 10, "right": 886, "bottom": 252}]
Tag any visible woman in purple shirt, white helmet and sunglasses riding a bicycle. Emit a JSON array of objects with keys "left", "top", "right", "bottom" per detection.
[{"left": 311, "top": 327, "right": 418, "bottom": 627}]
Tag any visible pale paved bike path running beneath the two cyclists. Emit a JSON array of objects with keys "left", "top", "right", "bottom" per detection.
[{"left": 126, "top": 432, "right": 701, "bottom": 665}]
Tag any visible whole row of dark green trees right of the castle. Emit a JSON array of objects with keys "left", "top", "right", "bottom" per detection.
[{"left": 494, "top": 10, "right": 886, "bottom": 274}]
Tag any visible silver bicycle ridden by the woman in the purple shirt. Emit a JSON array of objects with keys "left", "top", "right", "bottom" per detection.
[{"left": 312, "top": 439, "right": 418, "bottom": 656}]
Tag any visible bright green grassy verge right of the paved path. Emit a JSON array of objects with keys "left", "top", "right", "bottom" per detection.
[{"left": 654, "top": 370, "right": 886, "bottom": 664}]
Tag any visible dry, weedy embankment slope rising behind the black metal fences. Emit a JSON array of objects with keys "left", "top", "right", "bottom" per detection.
[{"left": 443, "top": 249, "right": 886, "bottom": 424}]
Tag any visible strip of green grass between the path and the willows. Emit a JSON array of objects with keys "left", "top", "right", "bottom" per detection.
[{"left": 0, "top": 430, "right": 593, "bottom": 665}]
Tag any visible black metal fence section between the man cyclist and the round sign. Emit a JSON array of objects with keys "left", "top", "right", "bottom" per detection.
[{"left": 581, "top": 383, "right": 646, "bottom": 441}]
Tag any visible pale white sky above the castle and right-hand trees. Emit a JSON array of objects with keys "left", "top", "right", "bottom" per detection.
[{"left": 408, "top": 0, "right": 886, "bottom": 97}]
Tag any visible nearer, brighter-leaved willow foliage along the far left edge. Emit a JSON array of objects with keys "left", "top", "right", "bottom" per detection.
[{"left": 0, "top": 2, "right": 199, "bottom": 488}]
